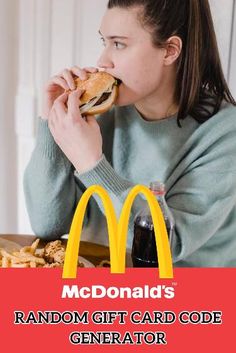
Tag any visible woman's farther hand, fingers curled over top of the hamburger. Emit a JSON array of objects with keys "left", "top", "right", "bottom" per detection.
[{"left": 42, "top": 66, "right": 98, "bottom": 120}]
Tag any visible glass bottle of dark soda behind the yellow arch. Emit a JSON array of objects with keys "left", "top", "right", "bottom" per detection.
[{"left": 131, "top": 181, "right": 174, "bottom": 267}]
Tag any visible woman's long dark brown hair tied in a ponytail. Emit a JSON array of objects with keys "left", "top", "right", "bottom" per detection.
[{"left": 107, "top": 0, "right": 236, "bottom": 126}]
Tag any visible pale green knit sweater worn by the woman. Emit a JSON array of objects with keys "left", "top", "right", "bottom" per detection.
[{"left": 24, "top": 105, "right": 236, "bottom": 267}]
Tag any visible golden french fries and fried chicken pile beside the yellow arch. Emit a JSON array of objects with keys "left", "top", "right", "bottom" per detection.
[{"left": 0, "top": 239, "right": 65, "bottom": 268}]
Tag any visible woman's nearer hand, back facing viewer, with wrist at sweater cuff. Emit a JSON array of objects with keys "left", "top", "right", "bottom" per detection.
[{"left": 48, "top": 89, "right": 102, "bottom": 173}]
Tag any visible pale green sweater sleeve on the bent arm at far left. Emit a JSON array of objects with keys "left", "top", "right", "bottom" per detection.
[{"left": 24, "top": 118, "right": 88, "bottom": 239}]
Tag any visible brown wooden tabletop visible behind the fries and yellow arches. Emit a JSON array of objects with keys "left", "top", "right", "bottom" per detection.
[{"left": 0, "top": 234, "right": 132, "bottom": 267}]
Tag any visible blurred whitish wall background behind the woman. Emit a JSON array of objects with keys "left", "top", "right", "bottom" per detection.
[{"left": 0, "top": 0, "right": 236, "bottom": 234}]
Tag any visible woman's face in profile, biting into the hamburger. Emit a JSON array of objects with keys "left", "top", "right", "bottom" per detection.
[{"left": 98, "top": 7, "right": 168, "bottom": 105}]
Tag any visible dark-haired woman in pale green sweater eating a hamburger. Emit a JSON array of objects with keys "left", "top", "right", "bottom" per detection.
[{"left": 25, "top": 0, "right": 236, "bottom": 267}]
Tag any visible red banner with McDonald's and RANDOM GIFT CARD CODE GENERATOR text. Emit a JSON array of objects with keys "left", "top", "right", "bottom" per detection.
[{"left": 0, "top": 268, "right": 236, "bottom": 353}]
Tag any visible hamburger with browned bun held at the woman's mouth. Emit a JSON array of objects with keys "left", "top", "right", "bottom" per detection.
[{"left": 75, "top": 71, "right": 120, "bottom": 115}]
